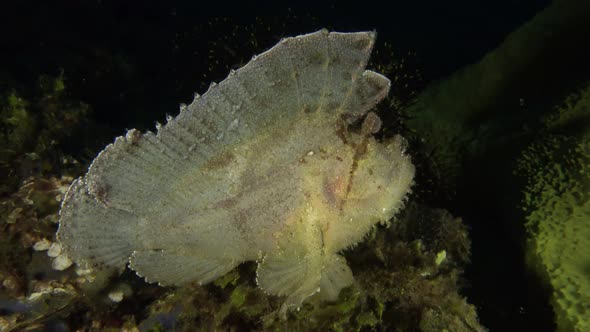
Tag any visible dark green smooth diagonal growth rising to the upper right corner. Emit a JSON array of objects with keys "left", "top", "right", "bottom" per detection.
[{"left": 405, "top": 1, "right": 590, "bottom": 198}]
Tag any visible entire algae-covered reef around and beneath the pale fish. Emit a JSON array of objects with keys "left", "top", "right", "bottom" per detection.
[{"left": 0, "top": 1, "right": 590, "bottom": 331}]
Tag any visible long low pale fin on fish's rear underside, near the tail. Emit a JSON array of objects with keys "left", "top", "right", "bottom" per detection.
[{"left": 129, "top": 249, "right": 240, "bottom": 286}]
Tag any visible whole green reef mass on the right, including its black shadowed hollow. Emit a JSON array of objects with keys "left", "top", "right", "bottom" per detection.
[{"left": 405, "top": 1, "right": 590, "bottom": 331}]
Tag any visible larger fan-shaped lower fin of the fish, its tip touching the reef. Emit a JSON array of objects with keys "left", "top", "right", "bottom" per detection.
[{"left": 256, "top": 252, "right": 321, "bottom": 316}]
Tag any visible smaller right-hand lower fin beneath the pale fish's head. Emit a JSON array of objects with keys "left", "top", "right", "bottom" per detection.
[{"left": 320, "top": 254, "right": 354, "bottom": 301}]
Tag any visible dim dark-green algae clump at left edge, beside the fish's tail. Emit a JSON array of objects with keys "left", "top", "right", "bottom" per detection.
[{"left": 0, "top": 74, "right": 90, "bottom": 194}]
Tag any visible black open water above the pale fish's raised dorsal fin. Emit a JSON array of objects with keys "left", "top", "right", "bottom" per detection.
[{"left": 0, "top": 0, "right": 549, "bottom": 140}]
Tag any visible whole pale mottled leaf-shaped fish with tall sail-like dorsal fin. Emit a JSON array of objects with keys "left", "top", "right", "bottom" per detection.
[{"left": 57, "top": 30, "right": 414, "bottom": 313}]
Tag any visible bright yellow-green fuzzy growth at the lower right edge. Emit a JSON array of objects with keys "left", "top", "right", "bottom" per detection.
[{"left": 519, "top": 81, "right": 590, "bottom": 331}]
